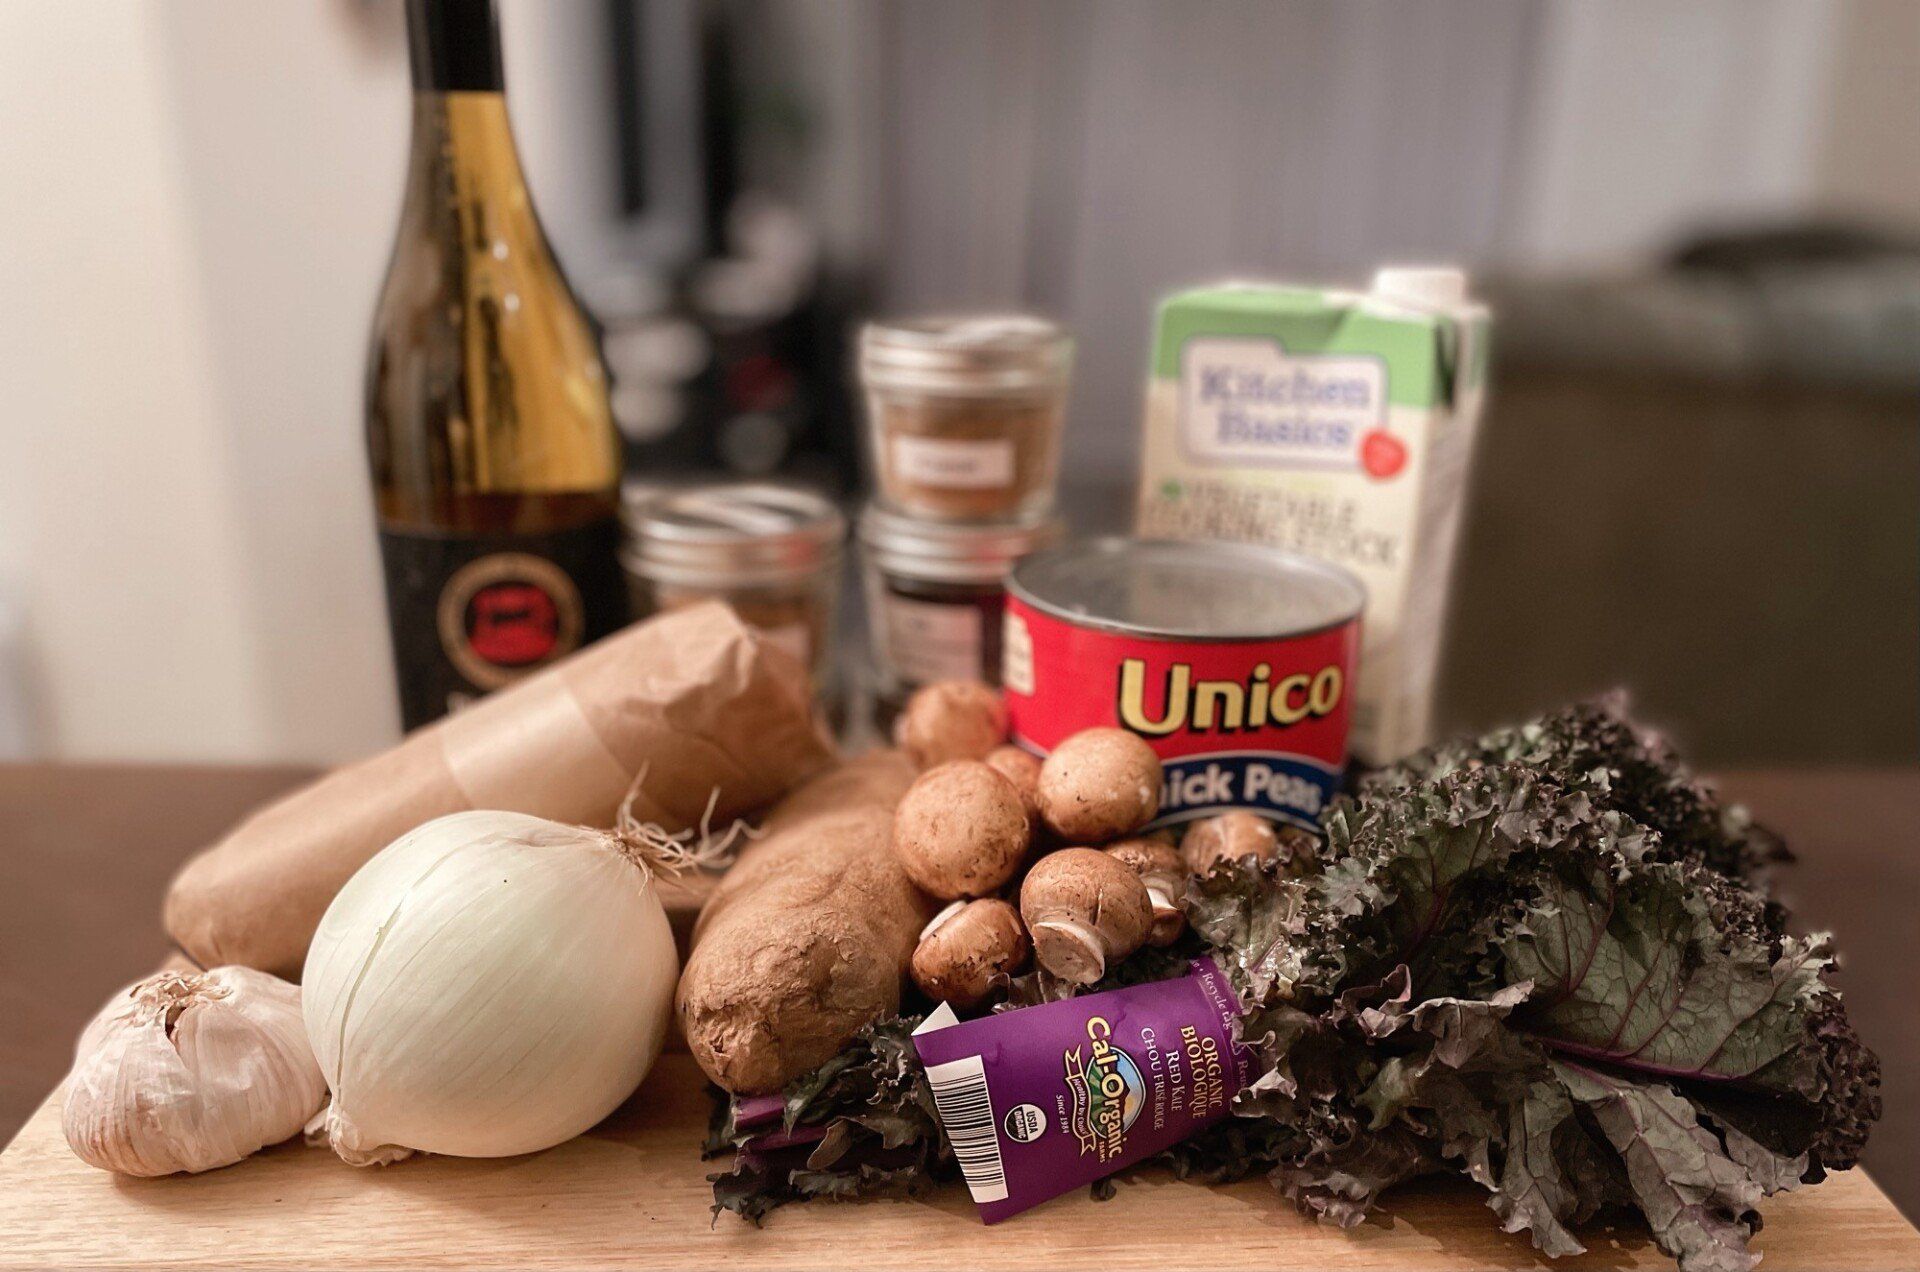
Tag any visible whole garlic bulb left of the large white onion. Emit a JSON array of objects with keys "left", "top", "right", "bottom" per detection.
[{"left": 61, "top": 966, "right": 326, "bottom": 1174}]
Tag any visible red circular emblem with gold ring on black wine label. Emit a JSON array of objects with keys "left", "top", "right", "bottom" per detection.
[{"left": 436, "top": 551, "right": 586, "bottom": 690}]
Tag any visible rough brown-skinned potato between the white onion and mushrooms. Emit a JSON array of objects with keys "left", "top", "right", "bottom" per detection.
[{"left": 676, "top": 751, "right": 933, "bottom": 1095}]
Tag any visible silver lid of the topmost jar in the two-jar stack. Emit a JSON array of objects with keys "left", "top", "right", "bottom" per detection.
[{"left": 860, "top": 313, "right": 1073, "bottom": 394}]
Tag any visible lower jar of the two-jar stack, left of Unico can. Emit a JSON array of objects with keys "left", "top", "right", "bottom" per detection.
[{"left": 858, "top": 503, "right": 1062, "bottom": 722}]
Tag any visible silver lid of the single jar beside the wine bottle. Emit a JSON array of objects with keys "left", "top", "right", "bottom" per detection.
[{"left": 620, "top": 482, "right": 847, "bottom": 584}]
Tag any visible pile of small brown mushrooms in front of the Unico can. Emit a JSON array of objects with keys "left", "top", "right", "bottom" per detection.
[{"left": 893, "top": 680, "right": 1315, "bottom": 1011}]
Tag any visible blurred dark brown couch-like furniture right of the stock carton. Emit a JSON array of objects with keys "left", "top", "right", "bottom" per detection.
[{"left": 1442, "top": 227, "right": 1920, "bottom": 765}]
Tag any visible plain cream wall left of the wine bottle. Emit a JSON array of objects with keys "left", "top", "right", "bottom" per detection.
[{"left": 0, "top": 0, "right": 405, "bottom": 759}]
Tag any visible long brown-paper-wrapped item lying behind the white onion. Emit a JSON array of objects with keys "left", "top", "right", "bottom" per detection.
[{"left": 165, "top": 603, "right": 833, "bottom": 978}]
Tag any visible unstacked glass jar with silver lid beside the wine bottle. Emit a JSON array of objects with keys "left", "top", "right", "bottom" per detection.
[{"left": 620, "top": 482, "right": 847, "bottom": 701}]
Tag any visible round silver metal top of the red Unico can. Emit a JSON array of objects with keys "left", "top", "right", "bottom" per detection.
[{"left": 1006, "top": 536, "right": 1367, "bottom": 640}]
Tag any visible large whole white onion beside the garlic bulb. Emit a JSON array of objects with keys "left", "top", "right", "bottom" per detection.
[{"left": 301, "top": 811, "right": 680, "bottom": 1164}]
